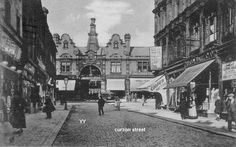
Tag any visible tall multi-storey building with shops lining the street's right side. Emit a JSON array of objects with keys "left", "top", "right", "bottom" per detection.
[{"left": 153, "top": 0, "right": 236, "bottom": 112}]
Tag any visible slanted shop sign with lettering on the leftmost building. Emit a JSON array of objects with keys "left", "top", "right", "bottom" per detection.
[{"left": 0, "top": 32, "right": 22, "bottom": 60}]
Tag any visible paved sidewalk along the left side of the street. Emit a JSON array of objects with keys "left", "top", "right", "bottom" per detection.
[{"left": 0, "top": 103, "right": 71, "bottom": 146}]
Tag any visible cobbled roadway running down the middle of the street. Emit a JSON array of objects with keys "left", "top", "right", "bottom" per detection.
[{"left": 53, "top": 103, "right": 236, "bottom": 147}]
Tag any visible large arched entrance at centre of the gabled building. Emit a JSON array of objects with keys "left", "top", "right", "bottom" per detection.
[{"left": 79, "top": 65, "right": 101, "bottom": 100}]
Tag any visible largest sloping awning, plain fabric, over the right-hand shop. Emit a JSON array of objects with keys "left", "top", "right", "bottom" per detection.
[{"left": 166, "top": 60, "right": 215, "bottom": 88}]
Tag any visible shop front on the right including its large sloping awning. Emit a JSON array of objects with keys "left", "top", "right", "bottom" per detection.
[{"left": 166, "top": 60, "right": 219, "bottom": 114}]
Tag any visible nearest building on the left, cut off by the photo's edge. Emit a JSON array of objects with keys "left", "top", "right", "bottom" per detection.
[{"left": 0, "top": 0, "right": 23, "bottom": 113}]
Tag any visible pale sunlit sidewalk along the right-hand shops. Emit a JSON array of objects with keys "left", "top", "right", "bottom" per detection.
[{"left": 121, "top": 99, "right": 236, "bottom": 138}]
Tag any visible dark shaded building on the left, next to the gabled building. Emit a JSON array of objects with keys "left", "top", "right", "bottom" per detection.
[{"left": 21, "top": 0, "right": 57, "bottom": 110}]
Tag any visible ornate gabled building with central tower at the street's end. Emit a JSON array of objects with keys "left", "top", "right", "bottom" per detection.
[{"left": 53, "top": 18, "right": 153, "bottom": 99}]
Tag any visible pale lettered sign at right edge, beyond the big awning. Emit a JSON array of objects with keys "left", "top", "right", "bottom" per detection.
[{"left": 222, "top": 61, "right": 236, "bottom": 81}]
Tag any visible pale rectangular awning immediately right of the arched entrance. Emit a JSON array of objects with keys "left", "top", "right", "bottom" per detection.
[{"left": 107, "top": 79, "right": 125, "bottom": 90}]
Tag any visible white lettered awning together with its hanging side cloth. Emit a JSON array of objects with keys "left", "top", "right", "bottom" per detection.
[{"left": 138, "top": 75, "right": 167, "bottom": 105}]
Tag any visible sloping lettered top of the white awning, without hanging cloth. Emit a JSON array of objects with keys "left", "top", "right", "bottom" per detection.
[{"left": 138, "top": 75, "right": 166, "bottom": 92}]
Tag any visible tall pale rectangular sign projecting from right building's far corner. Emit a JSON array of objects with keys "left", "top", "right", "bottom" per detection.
[{"left": 149, "top": 46, "right": 162, "bottom": 70}]
